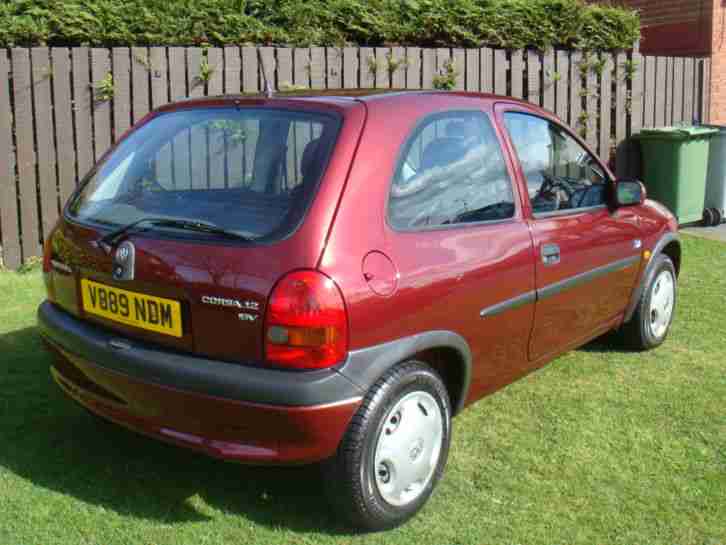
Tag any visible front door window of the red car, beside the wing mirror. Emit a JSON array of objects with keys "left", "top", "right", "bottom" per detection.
[{"left": 504, "top": 112, "right": 607, "bottom": 214}]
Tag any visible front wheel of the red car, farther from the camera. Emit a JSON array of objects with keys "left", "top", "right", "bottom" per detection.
[{"left": 622, "top": 254, "right": 678, "bottom": 350}]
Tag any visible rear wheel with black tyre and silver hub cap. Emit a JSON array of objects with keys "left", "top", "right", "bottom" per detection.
[{"left": 323, "top": 361, "right": 451, "bottom": 531}]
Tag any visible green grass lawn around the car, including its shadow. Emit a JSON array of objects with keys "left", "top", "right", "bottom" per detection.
[{"left": 0, "top": 237, "right": 726, "bottom": 545}]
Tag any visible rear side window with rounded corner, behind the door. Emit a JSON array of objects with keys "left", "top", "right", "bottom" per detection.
[{"left": 388, "top": 111, "right": 514, "bottom": 230}]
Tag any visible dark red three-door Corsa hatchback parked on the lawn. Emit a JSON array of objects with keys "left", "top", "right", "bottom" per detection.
[{"left": 38, "top": 92, "right": 681, "bottom": 529}]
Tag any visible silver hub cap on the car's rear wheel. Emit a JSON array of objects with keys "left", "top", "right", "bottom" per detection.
[{"left": 374, "top": 392, "right": 444, "bottom": 506}]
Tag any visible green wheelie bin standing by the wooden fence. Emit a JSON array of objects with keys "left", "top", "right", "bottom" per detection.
[{"left": 635, "top": 127, "right": 718, "bottom": 224}]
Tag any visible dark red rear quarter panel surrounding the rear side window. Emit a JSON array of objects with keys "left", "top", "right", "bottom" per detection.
[{"left": 320, "top": 94, "right": 534, "bottom": 401}]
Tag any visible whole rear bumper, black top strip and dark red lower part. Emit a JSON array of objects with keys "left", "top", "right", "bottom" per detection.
[{"left": 38, "top": 302, "right": 362, "bottom": 464}]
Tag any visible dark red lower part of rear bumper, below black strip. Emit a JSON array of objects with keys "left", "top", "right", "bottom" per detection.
[{"left": 46, "top": 343, "right": 360, "bottom": 463}]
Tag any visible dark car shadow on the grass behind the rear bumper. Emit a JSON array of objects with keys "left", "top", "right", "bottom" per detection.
[{"left": 0, "top": 328, "right": 345, "bottom": 534}]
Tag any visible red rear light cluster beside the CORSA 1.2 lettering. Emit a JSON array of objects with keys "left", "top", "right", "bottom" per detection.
[{"left": 265, "top": 271, "right": 348, "bottom": 369}]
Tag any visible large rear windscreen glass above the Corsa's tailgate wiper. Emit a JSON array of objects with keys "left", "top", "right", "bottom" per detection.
[{"left": 67, "top": 107, "right": 340, "bottom": 241}]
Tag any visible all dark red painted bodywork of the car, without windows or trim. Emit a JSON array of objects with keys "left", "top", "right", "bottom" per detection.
[{"left": 39, "top": 93, "right": 676, "bottom": 462}]
